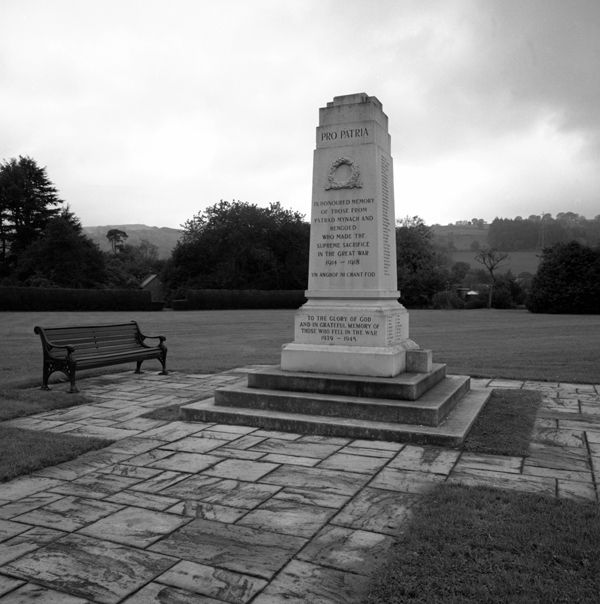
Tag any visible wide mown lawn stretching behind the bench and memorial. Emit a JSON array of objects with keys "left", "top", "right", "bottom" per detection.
[{"left": 0, "top": 309, "right": 600, "bottom": 385}]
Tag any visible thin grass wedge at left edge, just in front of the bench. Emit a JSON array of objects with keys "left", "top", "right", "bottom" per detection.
[{"left": 0, "top": 388, "right": 90, "bottom": 421}]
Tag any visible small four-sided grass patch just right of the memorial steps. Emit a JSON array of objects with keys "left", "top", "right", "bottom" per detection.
[{"left": 463, "top": 389, "right": 542, "bottom": 456}]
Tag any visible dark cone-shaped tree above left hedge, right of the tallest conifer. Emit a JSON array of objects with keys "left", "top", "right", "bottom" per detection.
[{"left": 15, "top": 208, "right": 106, "bottom": 288}]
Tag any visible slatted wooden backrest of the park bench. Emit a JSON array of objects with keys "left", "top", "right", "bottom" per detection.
[{"left": 35, "top": 321, "right": 141, "bottom": 354}]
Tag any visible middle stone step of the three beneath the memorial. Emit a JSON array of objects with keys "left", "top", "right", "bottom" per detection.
[{"left": 214, "top": 374, "right": 470, "bottom": 426}]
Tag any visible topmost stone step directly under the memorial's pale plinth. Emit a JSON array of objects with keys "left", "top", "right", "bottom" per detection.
[{"left": 248, "top": 363, "right": 446, "bottom": 401}]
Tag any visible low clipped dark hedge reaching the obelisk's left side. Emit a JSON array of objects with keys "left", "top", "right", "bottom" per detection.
[{"left": 173, "top": 289, "right": 306, "bottom": 310}]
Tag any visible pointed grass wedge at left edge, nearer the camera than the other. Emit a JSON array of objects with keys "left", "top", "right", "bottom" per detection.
[{"left": 0, "top": 426, "right": 113, "bottom": 482}]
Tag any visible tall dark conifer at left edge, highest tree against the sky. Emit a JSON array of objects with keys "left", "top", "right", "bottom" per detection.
[{"left": 0, "top": 156, "right": 62, "bottom": 261}]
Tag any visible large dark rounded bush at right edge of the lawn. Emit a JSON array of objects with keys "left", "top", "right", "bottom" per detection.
[{"left": 526, "top": 241, "right": 600, "bottom": 314}]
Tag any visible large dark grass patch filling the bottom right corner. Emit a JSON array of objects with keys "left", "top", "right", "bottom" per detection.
[{"left": 366, "top": 485, "right": 600, "bottom": 604}]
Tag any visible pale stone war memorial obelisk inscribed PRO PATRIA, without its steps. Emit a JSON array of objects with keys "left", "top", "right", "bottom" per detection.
[{"left": 281, "top": 93, "right": 431, "bottom": 377}]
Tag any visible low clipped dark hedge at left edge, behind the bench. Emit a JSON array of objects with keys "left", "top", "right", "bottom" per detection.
[{"left": 0, "top": 287, "right": 157, "bottom": 311}]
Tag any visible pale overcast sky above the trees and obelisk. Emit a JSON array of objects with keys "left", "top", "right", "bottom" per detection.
[{"left": 0, "top": 0, "right": 600, "bottom": 227}]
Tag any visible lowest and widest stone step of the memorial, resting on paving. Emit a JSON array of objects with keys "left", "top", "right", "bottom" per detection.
[{"left": 181, "top": 389, "right": 491, "bottom": 447}]
